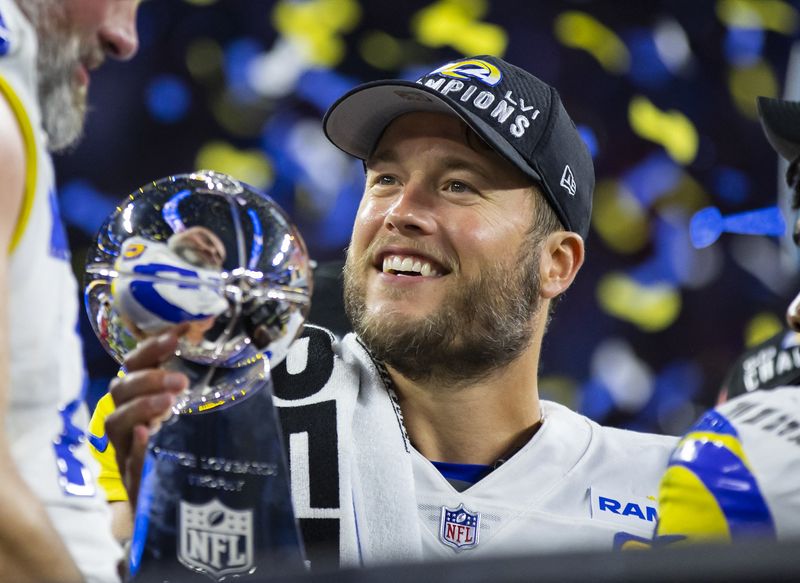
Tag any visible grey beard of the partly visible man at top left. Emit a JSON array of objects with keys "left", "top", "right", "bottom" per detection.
[{"left": 17, "top": 0, "right": 86, "bottom": 152}]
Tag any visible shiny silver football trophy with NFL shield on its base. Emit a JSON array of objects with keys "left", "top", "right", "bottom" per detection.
[{"left": 86, "top": 171, "right": 312, "bottom": 581}]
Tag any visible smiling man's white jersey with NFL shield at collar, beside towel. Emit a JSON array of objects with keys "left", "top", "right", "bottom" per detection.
[{"left": 412, "top": 401, "right": 676, "bottom": 559}]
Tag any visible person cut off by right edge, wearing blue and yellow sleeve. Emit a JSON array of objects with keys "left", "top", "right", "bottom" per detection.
[{"left": 655, "top": 97, "right": 800, "bottom": 544}]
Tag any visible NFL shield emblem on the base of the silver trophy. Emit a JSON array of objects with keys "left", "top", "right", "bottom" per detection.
[{"left": 178, "top": 499, "right": 253, "bottom": 581}]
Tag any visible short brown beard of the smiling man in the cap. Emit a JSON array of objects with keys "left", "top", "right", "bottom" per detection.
[{"left": 344, "top": 237, "right": 541, "bottom": 386}]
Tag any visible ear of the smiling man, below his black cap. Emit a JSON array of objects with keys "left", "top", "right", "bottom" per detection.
[{"left": 539, "top": 231, "right": 583, "bottom": 299}]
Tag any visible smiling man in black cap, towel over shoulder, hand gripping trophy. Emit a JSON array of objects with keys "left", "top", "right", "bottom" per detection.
[{"left": 106, "top": 56, "right": 675, "bottom": 564}]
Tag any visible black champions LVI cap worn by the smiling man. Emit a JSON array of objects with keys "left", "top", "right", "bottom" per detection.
[{"left": 322, "top": 55, "right": 594, "bottom": 239}]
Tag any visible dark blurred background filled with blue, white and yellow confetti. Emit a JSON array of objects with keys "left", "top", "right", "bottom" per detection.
[{"left": 62, "top": 0, "right": 800, "bottom": 433}]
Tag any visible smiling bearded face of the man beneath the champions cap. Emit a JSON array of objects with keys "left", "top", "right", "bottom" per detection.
[{"left": 345, "top": 113, "right": 540, "bottom": 382}]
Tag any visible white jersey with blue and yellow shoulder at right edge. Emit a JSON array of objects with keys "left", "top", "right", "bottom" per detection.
[{"left": 656, "top": 387, "right": 800, "bottom": 544}]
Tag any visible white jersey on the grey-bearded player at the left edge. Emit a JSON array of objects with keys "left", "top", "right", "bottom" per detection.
[{"left": 0, "top": 0, "right": 121, "bottom": 581}]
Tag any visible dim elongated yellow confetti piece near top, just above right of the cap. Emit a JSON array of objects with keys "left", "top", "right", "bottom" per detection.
[{"left": 554, "top": 10, "right": 631, "bottom": 73}]
